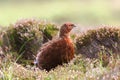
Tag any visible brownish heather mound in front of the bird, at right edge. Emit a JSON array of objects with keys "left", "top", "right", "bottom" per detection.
[{"left": 76, "top": 27, "right": 120, "bottom": 58}]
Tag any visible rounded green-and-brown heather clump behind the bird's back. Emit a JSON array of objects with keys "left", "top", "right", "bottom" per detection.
[{"left": 3, "top": 19, "right": 58, "bottom": 63}]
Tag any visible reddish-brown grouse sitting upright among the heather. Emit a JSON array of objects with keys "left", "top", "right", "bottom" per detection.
[{"left": 36, "top": 23, "right": 75, "bottom": 71}]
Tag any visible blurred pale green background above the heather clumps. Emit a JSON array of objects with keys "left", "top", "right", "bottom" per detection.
[{"left": 0, "top": 0, "right": 120, "bottom": 26}]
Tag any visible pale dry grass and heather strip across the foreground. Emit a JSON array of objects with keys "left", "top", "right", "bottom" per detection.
[{"left": 0, "top": 55, "right": 120, "bottom": 80}]
